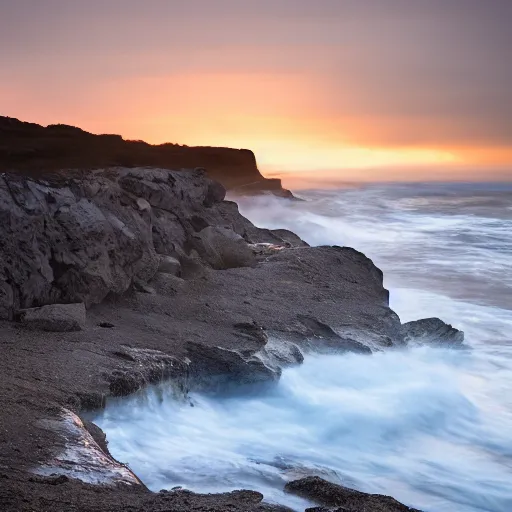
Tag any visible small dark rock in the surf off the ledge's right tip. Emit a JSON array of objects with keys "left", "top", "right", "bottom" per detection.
[{"left": 402, "top": 318, "right": 464, "bottom": 346}]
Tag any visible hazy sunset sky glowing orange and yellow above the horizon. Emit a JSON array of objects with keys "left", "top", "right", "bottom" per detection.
[{"left": 0, "top": 0, "right": 512, "bottom": 183}]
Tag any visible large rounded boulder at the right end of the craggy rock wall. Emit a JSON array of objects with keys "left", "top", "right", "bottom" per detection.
[{"left": 194, "top": 226, "right": 256, "bottom": 270}]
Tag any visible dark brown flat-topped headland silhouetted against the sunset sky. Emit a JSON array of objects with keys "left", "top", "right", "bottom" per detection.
[{"left": 0, "top": 117, "right": 289, "bottom": 196}]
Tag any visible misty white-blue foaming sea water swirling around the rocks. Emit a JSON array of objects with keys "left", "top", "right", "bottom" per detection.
[{"left": 92, "top": 185, "right": 512, "bottom": 512}]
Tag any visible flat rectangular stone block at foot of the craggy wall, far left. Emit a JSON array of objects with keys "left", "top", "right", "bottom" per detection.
[{"left": 19, "top": 303, "right": 85, "bottom": 332}]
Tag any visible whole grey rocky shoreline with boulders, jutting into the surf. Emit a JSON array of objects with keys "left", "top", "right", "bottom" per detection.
[{"left": 0, "top": 167, "right": 462, "bottom": 512}]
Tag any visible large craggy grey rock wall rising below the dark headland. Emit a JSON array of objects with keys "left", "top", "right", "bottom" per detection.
[{"left": 0, "top": 168, "right": 242, "bottom": 319}]
